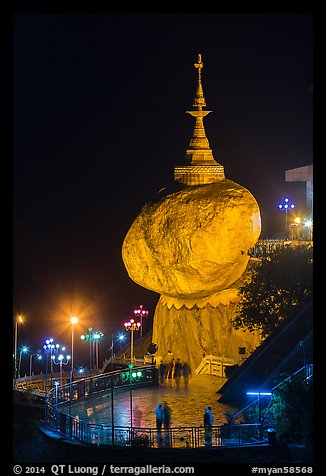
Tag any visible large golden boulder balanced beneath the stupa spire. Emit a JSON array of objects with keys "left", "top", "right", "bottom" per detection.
[{"left": 122, "top": 179, "right": 261, "bottom": 299}]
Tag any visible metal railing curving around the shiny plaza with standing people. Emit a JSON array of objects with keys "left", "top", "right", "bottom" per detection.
[{"left": 44, "top": 365, "right": 276, "bottom": 448}]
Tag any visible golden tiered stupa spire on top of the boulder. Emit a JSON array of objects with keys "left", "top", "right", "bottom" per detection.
[{"left": 174, "top": 53, "right": 225, "bottom": 185}]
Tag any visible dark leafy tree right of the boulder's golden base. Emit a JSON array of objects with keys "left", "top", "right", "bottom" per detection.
[{"left": 233, "top": 245, "right": 313, "bottom": 338}]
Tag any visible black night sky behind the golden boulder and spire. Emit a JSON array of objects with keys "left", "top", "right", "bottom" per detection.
[{"left": 12, "top": 12, "right": 313, "bottom": 368}]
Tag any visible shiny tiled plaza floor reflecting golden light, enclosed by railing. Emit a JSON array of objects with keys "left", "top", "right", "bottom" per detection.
[{"left": 65, "top": 375, "right": 234, "bottom": 428}]
